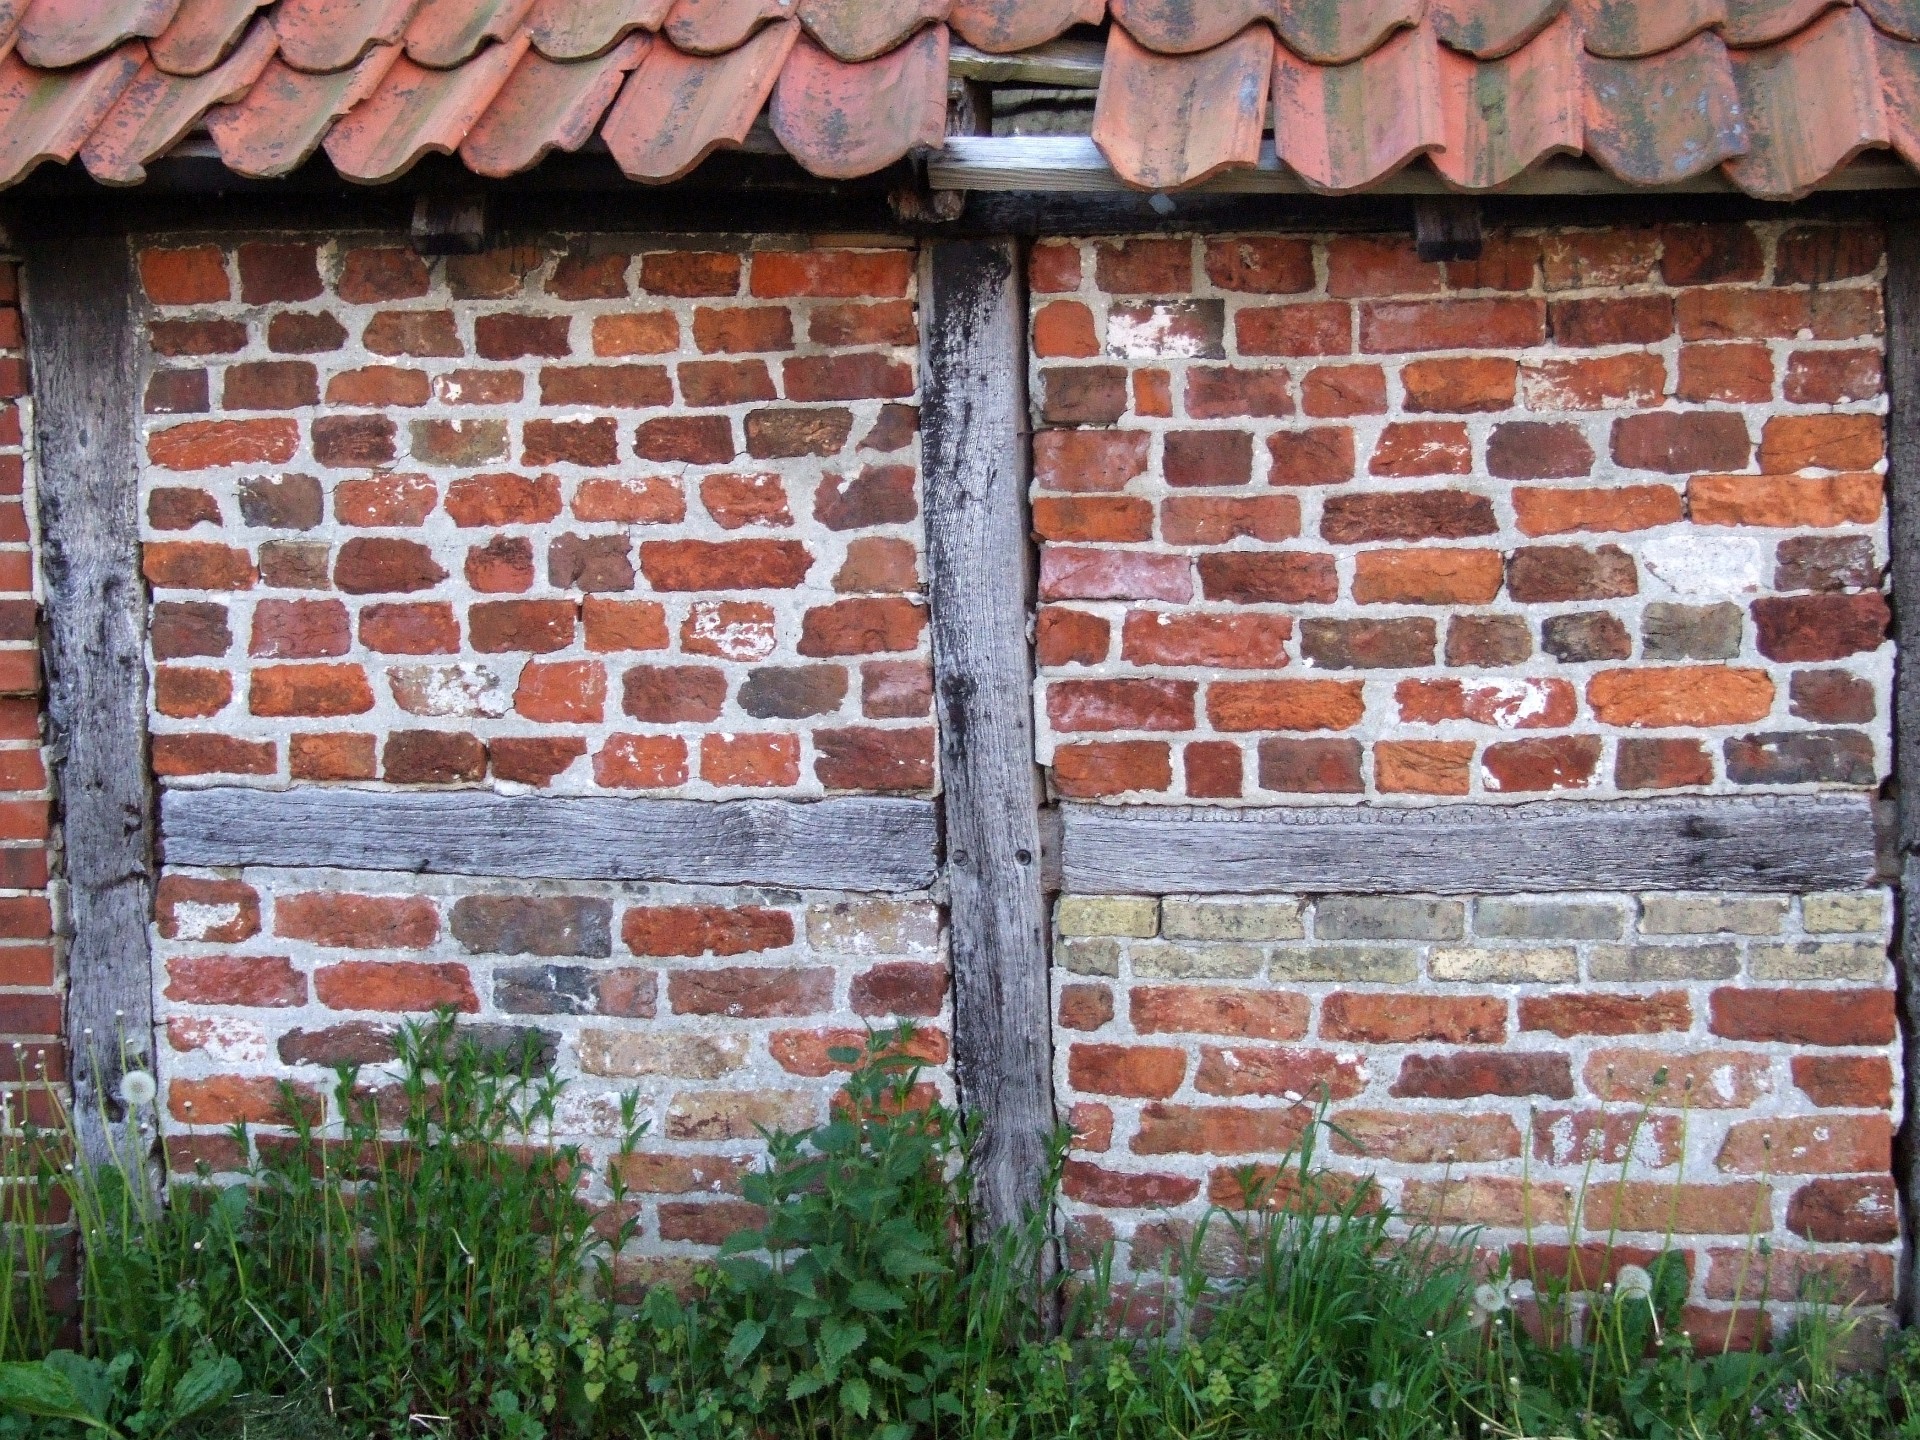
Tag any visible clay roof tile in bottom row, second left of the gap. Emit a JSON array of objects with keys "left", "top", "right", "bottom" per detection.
[{"left": 601, "top": 19, "right": 801, "bottom": 184}]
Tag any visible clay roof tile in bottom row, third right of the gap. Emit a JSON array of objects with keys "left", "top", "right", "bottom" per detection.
[{"left": 1430, "top": 15, "right": 1584, "bottom": 190}]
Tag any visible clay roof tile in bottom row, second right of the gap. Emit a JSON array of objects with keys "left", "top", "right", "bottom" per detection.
[{"left": 1273, "top": 27, "right": 1446, "bottom": 194}]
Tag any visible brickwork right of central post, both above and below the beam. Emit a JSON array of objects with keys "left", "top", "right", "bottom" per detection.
[{"left": 1031, "top": 225, "right": 1897, "bottom": 1342}]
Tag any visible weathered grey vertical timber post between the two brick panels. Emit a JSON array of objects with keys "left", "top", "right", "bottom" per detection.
[{"left": 920, "top": 240, "right": 1054, "bottom": 1225}]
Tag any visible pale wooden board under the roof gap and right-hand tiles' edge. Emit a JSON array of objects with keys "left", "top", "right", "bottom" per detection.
[{"left": 927, "top": 134, "right": 1920, "bottom": 196}]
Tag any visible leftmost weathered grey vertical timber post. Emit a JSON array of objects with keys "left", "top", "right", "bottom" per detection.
[{"left": 23, "top": 238, "right": 154, "bottom": 1160}]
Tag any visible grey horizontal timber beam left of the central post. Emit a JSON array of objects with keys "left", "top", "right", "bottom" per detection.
[{"left": 159, "top": 787, "right": 939, "bottom": 893}]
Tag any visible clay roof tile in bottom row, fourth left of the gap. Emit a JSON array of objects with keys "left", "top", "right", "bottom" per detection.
[{"left": 326, "top": 31, "right": 528, "bottom": 184}]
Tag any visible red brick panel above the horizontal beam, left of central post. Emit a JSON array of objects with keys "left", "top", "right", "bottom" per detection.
[{"left": 140, "top": 236, "right": 933, "bottom": 797}]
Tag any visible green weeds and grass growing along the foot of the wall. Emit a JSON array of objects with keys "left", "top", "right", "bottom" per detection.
[{"left": 0, "top": 1016, "right": 1920, "bottom": 1440}]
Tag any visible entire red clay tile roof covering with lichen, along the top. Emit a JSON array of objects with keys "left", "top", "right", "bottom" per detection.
[{"left": 0, "top": 0, "right": 1920, "bottom": 198}]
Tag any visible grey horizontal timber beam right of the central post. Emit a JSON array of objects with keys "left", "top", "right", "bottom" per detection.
[{"left": 1060, "top": 795, "right": 1876, "bottom": 895}]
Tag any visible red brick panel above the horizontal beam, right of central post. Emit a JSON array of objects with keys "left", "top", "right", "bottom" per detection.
[{"left": 1031, "top": 225, "right": 1891, "bottom": 803}]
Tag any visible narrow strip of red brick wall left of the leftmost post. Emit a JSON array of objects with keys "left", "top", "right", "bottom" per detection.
[{"left": 0, "top": 257, "right": 65, "bottom": 1114}]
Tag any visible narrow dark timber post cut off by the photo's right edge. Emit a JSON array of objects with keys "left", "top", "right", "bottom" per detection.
[{"left": 1885, "top": 217, "right": 1920, "bottom": 1323}]
